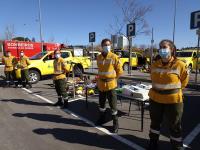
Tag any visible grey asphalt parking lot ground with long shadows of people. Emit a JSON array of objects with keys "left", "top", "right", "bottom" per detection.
[{"left": 0, "top": 75, "right": 200, "bottom": 150}]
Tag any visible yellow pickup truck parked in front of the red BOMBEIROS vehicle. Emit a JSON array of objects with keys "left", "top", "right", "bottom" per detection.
[{"left": 28, "top": 50, "right": 91, "bottom": 83}]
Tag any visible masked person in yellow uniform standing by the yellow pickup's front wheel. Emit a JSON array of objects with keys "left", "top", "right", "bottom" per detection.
[{"left": 18, "top": 51, "right": 32, "bottom": 88}]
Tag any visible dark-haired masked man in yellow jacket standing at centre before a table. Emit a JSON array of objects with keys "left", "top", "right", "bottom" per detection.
[{"left": 96, "top": 39, "right": 123, "bottom": 133}]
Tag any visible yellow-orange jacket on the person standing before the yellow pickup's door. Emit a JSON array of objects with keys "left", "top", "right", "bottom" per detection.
[{"left": 53, "top": 57, "right": 70, "bottom": 80}]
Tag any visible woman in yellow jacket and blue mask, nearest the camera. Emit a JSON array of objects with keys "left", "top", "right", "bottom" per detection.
[{"left": 148, "top": 40, "right": 189, "bottom": 150}]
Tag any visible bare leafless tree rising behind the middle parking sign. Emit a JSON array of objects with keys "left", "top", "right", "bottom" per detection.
[{"left": 109, "top": 0, "right": 152, "bottom": 36}]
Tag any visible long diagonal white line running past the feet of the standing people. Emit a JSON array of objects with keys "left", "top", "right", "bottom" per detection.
[{"left": 22, "top": 88, "right": 145, "bottom": 150}]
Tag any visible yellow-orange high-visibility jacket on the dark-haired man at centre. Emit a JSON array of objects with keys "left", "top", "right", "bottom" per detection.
[{"left": 97, "top": 52, "right": 123, "bottom": 91}]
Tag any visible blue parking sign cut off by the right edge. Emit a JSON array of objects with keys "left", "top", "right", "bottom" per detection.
[{"left": 190, "top": 11, "right": 200, "bottom": 29}]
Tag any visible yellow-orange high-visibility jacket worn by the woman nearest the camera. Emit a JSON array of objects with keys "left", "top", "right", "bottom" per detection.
[{"left": 149, "top": 59, "right": 189, "bottom": 104}]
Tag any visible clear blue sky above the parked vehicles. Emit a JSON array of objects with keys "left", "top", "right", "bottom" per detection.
[{"left": 0, "top": 0, "right": 200, "bottom": 48}]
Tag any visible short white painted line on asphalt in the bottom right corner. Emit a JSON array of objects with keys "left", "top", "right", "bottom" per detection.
[{"left": 183, "top": 123, "right": 200, "bottom": 149}]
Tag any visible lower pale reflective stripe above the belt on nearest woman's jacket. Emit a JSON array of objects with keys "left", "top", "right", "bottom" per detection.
[{"left": 152, "top": 82, "right": 181, "bottom": 90}]
